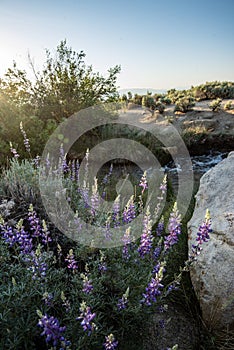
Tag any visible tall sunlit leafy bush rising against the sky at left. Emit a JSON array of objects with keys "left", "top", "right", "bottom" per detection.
[{"left": 0, "top": 40, "right": 120, "bottom": 123}]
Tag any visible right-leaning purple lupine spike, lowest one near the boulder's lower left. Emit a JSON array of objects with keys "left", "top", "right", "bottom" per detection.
[{"left": 141, "top": 264, "right": 164, "bottom": 306}]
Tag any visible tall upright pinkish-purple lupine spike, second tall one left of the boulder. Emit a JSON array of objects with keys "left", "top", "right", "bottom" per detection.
[{"left": 138, "top": 207, "right": 153, "bottom": 258}]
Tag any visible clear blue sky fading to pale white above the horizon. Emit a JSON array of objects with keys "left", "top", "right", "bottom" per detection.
[{"left": 0, "top": 0, "right": 234, "bottom": 89}]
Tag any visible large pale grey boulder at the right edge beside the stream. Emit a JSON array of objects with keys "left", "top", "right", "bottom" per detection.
[{"left": 188, "top": 152, "right": 234, "bottom": 331}]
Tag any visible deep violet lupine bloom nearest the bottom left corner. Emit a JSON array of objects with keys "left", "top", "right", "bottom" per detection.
[{"left": 38, "top": 314, "right": 66, "bottom": 346}]
